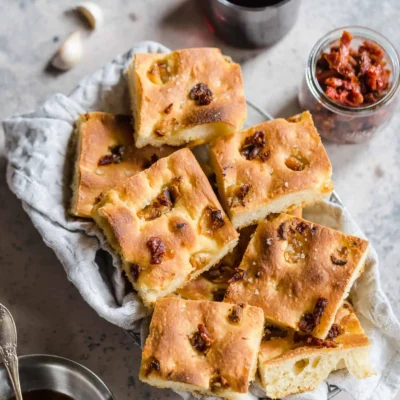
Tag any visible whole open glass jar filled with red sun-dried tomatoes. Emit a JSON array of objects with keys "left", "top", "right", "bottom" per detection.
[{"left": 299, "top": 26, "right": 399, "bottom": 143}]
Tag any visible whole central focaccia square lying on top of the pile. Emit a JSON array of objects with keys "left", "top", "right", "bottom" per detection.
[{"left": 92, "top": 149, "right": 238, "bottom": 305}]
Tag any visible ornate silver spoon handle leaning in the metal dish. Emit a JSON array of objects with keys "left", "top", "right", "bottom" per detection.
[{"left": 0, "top": 304, "right": 22, "bottom": 400}]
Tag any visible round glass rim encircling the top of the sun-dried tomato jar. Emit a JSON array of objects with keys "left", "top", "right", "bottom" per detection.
[{"left": 306, "top": 25, "right": 400, "bottom": 116}]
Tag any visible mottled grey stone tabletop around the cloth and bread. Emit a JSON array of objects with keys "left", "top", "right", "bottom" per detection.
[{"left": 0, "top": 0, "right": 400, "bottom": 400}]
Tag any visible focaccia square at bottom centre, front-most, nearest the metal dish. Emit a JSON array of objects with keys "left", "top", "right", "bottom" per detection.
[{"left": 139, "top": 298, "right": 264, "bottom": 399}]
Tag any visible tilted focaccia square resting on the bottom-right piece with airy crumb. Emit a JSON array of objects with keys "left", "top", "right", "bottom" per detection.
[{"left": 225, "top": 214, "right": 369, "bottom": 339}]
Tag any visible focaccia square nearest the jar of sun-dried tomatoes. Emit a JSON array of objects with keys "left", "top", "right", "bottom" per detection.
[{"left": 210, "top": 111, "right": 333, "bottom": 228}]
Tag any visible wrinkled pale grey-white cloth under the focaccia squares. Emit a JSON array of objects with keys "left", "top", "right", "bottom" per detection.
[{"left": 3, "top": 42, "right": 400, "bottom": 400}]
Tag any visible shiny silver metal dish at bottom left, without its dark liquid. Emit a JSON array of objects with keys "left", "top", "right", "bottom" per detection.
[{"left": 0, "top": 354, "right": 115, "bottom": 400}]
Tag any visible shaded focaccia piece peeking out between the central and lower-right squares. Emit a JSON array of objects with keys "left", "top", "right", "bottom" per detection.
[{"left": 176, "top": 226, "right": 256, "bottom": 301}]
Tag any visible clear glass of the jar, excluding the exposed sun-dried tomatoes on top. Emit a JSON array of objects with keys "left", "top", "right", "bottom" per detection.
[{"left": 299, "top": 26, "right": 400, "bottom": 143}]
